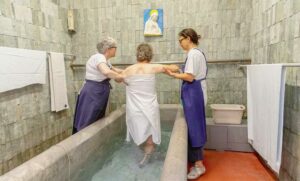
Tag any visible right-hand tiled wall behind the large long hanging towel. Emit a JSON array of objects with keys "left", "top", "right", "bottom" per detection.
[{"left": 250, "top": 0, "right": 300, "bottom": 180}]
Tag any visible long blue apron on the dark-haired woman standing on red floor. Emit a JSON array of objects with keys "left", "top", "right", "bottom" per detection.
[{"left": 181, "top": 50, "right": 207, "bottom": 147}]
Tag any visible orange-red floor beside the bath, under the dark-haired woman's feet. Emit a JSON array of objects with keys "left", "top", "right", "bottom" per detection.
[{"left": 189, "top": 150, "right": 276, "bottom": 181}]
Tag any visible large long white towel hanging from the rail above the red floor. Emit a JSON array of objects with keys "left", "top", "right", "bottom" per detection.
[{"left": 247, "top": 64, "right": 285, "bottom": 173}]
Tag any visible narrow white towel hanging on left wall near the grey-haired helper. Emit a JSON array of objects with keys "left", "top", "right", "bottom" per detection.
[{"left": 49, "top": 52, "right": 69, "bottom": 112}]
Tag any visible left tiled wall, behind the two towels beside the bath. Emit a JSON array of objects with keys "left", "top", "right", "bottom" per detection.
[{"left": 0, "top": 0, "right": 74, "bottom": 175}]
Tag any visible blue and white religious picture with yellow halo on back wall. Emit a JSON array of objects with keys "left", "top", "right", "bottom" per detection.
[{"left": 144, "top": 9, "right": 163, "bottom": 36}]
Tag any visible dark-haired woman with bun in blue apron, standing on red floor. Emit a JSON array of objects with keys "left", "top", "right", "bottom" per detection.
[{"left": 168, "top": 28, "right": 207, "bottom": 179}]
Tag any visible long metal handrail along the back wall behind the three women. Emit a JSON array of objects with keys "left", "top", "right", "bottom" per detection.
[{"left": 70, "top": 59, "right": 251, "bottom": 69}]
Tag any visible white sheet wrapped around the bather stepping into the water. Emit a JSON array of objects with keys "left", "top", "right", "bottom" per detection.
[{"left": 125, "top": 74, "right": 161, "bottom": 145}]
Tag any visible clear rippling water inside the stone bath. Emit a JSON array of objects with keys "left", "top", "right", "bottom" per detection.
[{"left": 76, "top": 122, "right": 173, "bottom": 181}]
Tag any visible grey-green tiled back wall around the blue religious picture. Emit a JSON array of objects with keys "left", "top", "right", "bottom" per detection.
[{"left": 72, "top": 0, "right": 251, "bottom": 115}]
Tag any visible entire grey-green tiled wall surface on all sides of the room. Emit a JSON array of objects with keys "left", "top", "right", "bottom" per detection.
[{"left": 0, "top": 0, "right": 300, "bottom": 180}]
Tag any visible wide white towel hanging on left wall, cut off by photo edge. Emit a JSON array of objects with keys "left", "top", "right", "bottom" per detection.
[{"left": 0, "top": 47, "right": 46, "bottom": 92}]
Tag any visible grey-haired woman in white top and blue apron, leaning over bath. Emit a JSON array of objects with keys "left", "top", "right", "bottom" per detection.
[{"left": 73, "top": 37, "right": 123, "bottom": 134}]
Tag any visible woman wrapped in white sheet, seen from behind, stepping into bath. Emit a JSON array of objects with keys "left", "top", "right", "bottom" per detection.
[{"left": 122, "top": 43, "right": 178, "bottom": 167}]
